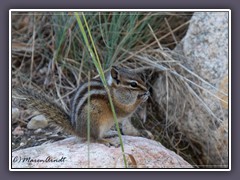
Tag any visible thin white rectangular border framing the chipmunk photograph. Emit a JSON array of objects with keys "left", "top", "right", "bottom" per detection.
[{"left": 9, "top": 9, "right": 231, "bottom": 171}]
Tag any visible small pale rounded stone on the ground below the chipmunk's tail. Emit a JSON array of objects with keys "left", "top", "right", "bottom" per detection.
[{"left": 27, "top": 115, "right": 48, "bottom": 129}]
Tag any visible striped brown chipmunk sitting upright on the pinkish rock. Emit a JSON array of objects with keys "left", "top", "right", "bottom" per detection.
[{"left": 16, "top": 66, "right": 150, "bottom": 145}]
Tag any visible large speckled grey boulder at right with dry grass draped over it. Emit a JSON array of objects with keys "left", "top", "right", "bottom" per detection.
[{"left": 154, "top": 12, "right": 229, "bottom": 168}]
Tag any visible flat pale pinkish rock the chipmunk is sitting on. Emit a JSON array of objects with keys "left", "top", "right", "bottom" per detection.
[{"left": 12, "top": 136, "right": 192, "bottom": 168}]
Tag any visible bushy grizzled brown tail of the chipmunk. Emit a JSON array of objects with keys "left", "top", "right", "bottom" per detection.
[{"left": 13, "top": 88, "right": 76, "bottom": 135}]
